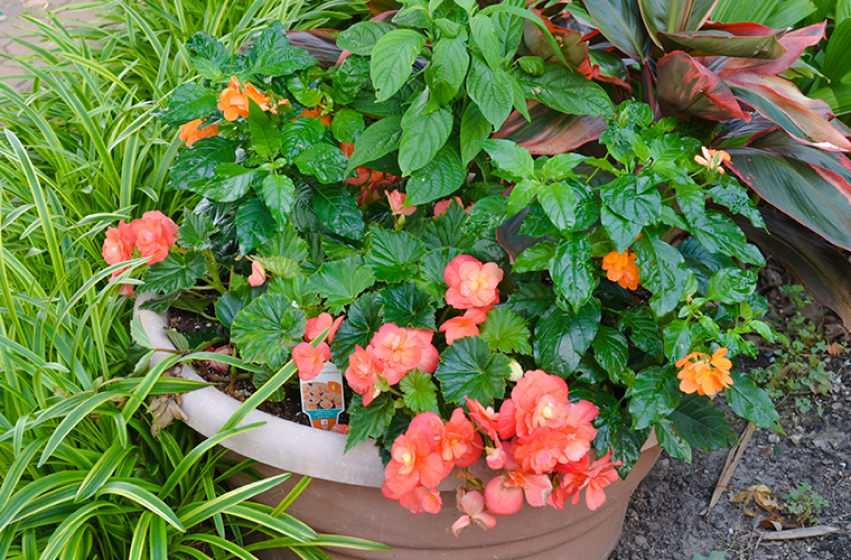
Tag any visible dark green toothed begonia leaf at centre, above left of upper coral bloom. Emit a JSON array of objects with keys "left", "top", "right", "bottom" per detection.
[{"left": 365, "top": 228, "right": 426, "bottom": 284}]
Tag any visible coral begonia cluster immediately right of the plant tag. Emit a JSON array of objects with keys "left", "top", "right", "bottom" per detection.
[{"left": 346, "top": 323, "right": 440, "bottom": 406}]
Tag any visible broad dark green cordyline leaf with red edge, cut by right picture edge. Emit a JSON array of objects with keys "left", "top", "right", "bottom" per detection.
[{"left": 727, "top": 131, "right": 851, "bottom": 249}]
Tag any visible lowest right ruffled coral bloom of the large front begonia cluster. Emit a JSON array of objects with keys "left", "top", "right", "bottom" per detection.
[{"left": 549, "top": 453, "right": 621, "bottom": 511}]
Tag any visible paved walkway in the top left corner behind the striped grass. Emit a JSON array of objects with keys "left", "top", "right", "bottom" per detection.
[{"left": 0, "top": 0, "right": 93, "bottom": 86}]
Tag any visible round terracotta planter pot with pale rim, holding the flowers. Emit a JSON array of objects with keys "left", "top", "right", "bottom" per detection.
[{"left": 135, "top": 294, "right": 661, "bottom": 560}]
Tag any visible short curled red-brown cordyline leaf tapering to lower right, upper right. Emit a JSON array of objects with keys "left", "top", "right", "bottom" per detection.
[{"left": 656, "top": 51, "right": 750, "bottom": 121}]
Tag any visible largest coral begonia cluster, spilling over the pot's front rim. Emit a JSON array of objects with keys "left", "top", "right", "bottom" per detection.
[{"left": 382, "top": 370, "right": 620, "bottom": 534}]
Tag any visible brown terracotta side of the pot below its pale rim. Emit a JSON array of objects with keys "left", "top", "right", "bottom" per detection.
[{"left": 229, "top": 445, "right": 661, "bottom": 560}]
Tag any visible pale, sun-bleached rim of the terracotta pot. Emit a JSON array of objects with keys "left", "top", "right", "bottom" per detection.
[{"left": 133, "top": 292, "right": 658, "bottom": 490}]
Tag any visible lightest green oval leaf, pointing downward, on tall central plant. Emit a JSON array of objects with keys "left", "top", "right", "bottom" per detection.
[{"left": 369, "top": 29, "right": 425, "bottom": 101}]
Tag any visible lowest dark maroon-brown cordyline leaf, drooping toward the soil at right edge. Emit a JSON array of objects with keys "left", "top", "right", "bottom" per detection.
[{"left": 734, "top": 206, "right": 851, "bottom": 328}]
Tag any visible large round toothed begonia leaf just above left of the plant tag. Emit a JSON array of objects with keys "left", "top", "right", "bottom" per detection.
[{"left": 231, "top": 294, "right": 307, "bottom": 369}]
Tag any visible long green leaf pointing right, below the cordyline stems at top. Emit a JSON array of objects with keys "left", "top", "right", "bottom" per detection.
[{"left": 512, "top": 64, "right": 613, "bottom": 117}]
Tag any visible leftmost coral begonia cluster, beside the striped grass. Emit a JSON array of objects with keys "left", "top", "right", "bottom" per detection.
[{"left": 101, "top": 210, "right": 178, "bottom": 295}]
